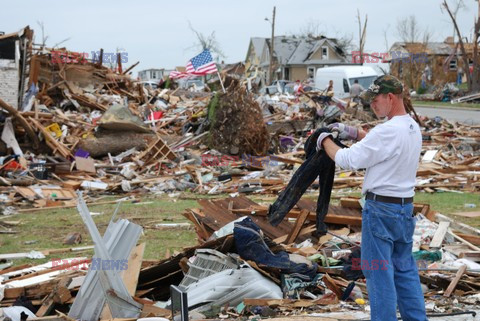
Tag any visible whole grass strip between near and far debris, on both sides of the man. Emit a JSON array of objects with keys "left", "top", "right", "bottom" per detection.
[{"left": 0, "top": 193, "right": 480, "bottom": 265}]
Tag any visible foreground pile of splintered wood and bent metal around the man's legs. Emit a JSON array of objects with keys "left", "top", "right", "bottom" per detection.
[{"left": 0, "top": 197, "right": 480, "bottom": 320}]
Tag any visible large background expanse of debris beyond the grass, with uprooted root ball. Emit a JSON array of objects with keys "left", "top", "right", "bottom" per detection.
[{"left": 0, "top": 26, "right": 480, "bottom": 211}]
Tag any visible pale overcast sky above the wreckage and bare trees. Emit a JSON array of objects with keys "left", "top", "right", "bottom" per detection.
[{"left": 0, "top": 0, "right": 477, "bottom": 72}]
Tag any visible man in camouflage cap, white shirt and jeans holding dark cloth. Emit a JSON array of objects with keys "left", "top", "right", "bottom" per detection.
[{"left": 317, "top": 75, "right": 427, "bottom": 321}]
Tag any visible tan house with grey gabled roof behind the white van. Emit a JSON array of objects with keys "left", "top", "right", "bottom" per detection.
[{"left": 245, "top": 36, "right": 353, "bottom": 85}]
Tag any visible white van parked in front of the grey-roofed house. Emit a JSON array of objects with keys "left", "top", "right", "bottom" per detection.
[{"left": 315, "top": 66, "right": 379, "bottom": 98}]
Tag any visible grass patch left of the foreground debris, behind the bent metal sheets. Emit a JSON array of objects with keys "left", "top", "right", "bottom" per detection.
[{"left": 0, "top": 196, "right": 223, "bottom": 264}]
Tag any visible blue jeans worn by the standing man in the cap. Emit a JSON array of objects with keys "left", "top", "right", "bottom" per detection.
[{"left": 361, "top": 200, "right": 427, "bottom": 321}]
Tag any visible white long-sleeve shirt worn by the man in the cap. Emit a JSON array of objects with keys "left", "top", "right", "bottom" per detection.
[{"left": 335, "top": 115, "right": 422, "bottom": 197}]
